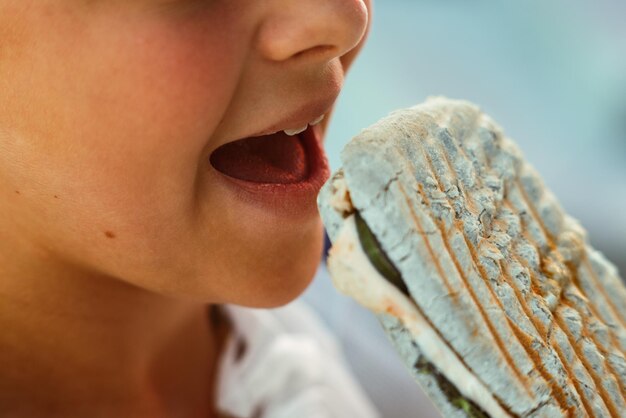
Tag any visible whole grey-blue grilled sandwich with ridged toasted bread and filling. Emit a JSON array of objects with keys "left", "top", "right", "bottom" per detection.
[{"left": 318, "top": 97, "right": 626, "bottom": 418}]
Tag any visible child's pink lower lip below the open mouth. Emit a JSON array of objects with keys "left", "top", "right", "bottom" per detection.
[{"left": 211, "top": 125, "right": 330, "bottom": 216}]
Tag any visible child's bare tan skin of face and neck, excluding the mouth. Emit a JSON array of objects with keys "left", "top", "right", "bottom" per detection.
[{"left": 0, "top": 0, "right": 371, "bottom": 417}]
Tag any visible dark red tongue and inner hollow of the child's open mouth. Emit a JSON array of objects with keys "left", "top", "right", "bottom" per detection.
[{"left": 210, "top": 131, "right": 308, "bottom": 183}]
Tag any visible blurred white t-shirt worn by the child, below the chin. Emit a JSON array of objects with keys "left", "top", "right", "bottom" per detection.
[{"left": 217, "top": 301, "right": 380, "bottom": 418}]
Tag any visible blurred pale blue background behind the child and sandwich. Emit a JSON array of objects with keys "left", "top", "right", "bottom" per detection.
[{"left": 304, "top": 0, "right": 626, "bottom": 418}]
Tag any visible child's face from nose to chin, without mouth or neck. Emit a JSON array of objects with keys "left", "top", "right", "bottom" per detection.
[{"left": 0, "top": 0, "right": 369, "bottom": 306}]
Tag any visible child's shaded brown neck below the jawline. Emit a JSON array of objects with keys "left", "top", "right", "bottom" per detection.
[{"left": 0, "top": 235, "right": 223, "bottom": 416}]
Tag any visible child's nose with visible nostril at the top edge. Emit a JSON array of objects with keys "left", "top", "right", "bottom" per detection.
[{"left": 257, "top": 0, "right": 368, "bottom": 61}]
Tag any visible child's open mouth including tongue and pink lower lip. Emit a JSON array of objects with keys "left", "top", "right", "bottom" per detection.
[{"left": 209, "top": 121, "right": 329, "bottom": 217}]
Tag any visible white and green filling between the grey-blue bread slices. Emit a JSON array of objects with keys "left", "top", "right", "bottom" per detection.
[{"left": 328, "top": 213, "right": 509, "bottom": 418}]
